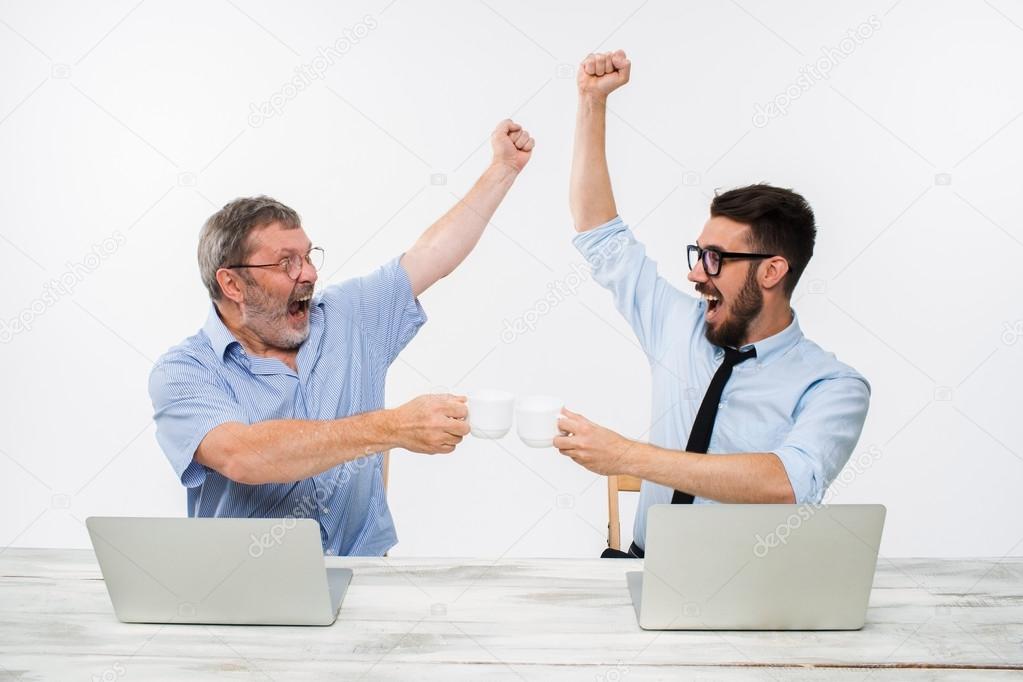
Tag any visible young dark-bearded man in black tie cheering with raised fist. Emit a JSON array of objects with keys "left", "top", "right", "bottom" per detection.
[{"left": 554, "top": 51, "right": 870, "bottom": 556}]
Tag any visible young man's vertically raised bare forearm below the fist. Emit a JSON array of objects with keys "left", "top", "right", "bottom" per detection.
[{"left": 569, "top": 94, "right": 618, "bottom": 232}]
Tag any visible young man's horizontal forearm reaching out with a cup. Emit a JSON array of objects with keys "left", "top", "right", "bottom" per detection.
[{"left": 625, "top": 443, "right": 796, "bottom": 504}]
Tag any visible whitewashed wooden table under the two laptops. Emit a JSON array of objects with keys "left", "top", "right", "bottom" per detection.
[{"left": 0, "top": 549, "right": 1023, "bottom": 682}]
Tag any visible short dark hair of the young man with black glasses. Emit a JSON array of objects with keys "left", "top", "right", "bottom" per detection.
[{"left": 710, "top": 183, "right": 817, "bottom": 297}]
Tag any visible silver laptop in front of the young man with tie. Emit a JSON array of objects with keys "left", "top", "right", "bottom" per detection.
[{"left": 626, "top": 504, "right": 885, "bottom": 630}]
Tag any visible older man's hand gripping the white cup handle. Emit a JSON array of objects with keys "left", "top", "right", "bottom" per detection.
[{"left": 394, "top": 395, "right": 469, "bottom": 455}]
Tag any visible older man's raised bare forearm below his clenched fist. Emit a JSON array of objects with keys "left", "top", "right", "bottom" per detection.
[{"left": 402, "top": 163, "right": 519, "bottom": 295}]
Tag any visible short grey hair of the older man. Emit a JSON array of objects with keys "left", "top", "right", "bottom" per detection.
[{"left": 198, "top": 195, "right": 302, "bottom": 301}]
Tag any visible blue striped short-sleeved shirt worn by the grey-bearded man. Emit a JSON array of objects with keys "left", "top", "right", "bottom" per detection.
[{"left": 149, "top": 258, "right": 427, "bottom": 556}]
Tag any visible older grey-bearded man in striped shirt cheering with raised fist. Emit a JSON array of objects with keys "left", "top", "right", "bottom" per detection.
[{"left": 149, "top": 121, "right": 534, "bottom": 555}]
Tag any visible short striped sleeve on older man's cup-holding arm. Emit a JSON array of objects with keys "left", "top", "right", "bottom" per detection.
[{"left": 149, "top": 353, "right": 249, "bottom": 488}]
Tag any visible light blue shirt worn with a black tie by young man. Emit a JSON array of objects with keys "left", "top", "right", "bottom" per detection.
[{"left": 574, "top": 218, "right": 871, "bottom": 547}]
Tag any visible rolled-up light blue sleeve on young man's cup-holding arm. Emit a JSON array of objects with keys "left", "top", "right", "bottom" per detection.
[{"left": 772, "top": 376, "right": 871, "bottom": 504}]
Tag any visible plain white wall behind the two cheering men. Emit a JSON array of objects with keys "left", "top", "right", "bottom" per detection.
[{"left": 0, "top": 0, "right": 1023, "bottom": 556}]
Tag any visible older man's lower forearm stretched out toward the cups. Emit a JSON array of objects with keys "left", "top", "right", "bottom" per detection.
[{"left": 196, "top": 410, "right": 398, "bottom": 485}]
